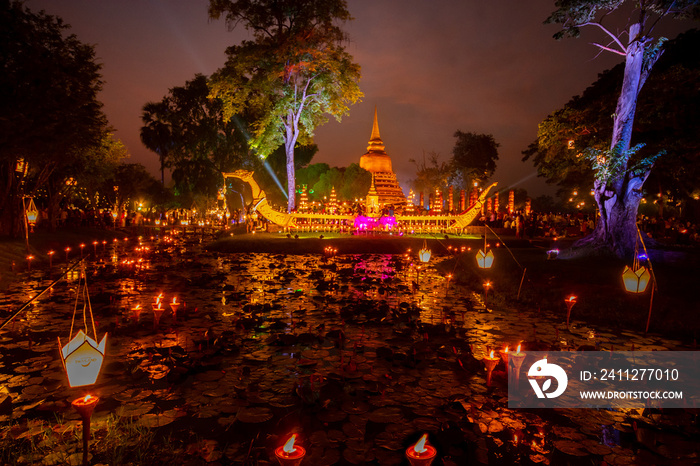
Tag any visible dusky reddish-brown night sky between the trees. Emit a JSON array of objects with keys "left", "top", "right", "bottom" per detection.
[{"left": 26, "top": 0, "right": 693, "bottom": 196}]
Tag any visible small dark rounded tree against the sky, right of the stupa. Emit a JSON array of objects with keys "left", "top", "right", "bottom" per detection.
[{"left": 451, "top": 131, "right": 499, "bottom": 187}]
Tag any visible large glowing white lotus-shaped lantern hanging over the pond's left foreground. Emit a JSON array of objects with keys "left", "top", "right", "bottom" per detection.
[{"left": 58, "top": 270, "right": 107, "bottom": 387}]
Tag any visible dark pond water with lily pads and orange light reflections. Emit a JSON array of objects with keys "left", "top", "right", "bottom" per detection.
[{"left": 0, "top": 236, "right": 700, "bottom": 465}]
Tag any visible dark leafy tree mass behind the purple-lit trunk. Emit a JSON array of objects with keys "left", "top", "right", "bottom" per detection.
[{"left": 523, "top": 29, "right": 700, "bottom": 217}]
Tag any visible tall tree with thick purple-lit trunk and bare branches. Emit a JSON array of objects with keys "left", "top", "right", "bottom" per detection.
[{"left": 546, "top": 0, "right": 699, "bottom": 258}]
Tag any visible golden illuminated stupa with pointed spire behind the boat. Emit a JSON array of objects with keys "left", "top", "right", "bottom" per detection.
[{"left": 360, "top": 107, "right": 406, "bottom": 207}]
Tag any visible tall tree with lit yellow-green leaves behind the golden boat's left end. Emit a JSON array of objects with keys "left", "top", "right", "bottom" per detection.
[{"left": 209, "top": 0, "right": 362, "bottom": 211}]
